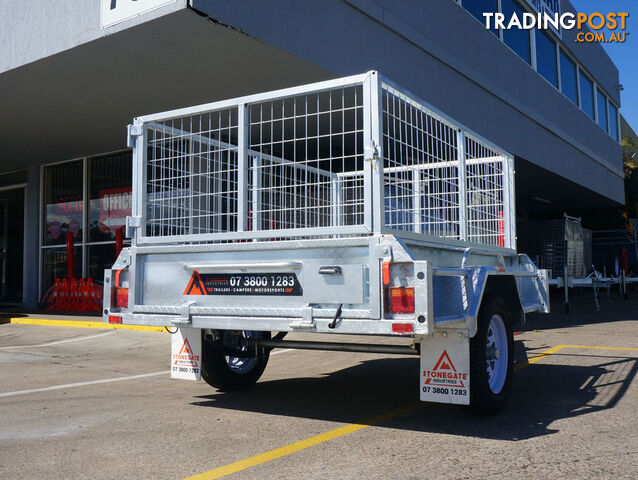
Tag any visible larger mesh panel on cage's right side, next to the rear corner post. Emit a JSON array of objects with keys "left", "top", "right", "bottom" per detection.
[{"left": 382, "top": 86, "right": 460, "bottom": 239}]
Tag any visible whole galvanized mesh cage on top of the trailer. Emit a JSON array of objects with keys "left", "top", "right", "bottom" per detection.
[{"left": 133, "top": 72, "right": 514, "bottom": 248}]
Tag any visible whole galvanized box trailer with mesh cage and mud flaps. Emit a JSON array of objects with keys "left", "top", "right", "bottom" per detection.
[{"left": 104, "top": 71, "right": 549, "bottom": 412}]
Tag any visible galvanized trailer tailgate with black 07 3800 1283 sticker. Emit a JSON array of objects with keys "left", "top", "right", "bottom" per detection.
[{"left": 134, "top": 238, "right": 380, "bottom": 318}]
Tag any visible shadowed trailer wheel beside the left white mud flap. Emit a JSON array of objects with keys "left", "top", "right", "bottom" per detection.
[{"left": 202, "top": 331, "right": 270, "bottom": 391}]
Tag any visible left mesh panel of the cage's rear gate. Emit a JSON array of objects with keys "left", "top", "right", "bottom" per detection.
[{"left": 146, "top": 107, "right": 238, "bottom": 236}]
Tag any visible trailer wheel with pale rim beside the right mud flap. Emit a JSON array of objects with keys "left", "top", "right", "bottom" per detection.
[{"left": 470, "top": 295, "right": 514, "bottom": 415}]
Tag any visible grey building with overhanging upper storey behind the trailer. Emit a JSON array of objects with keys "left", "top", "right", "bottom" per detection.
[{"left": 0, "top": 0, "right": 624, "bottom": 307}]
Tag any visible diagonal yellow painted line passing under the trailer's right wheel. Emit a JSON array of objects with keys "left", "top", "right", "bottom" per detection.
[{"left": 183, "top": 345, "right": 564, "bottom": 480}]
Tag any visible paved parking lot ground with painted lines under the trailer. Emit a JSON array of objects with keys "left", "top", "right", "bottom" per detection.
[{"left": 0, "top": 300, "right": 638, "bottom": 479}]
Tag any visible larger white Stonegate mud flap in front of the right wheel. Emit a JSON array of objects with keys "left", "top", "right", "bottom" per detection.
[{"left": 419, "top": 331, "right": 470, "bottom": 405}]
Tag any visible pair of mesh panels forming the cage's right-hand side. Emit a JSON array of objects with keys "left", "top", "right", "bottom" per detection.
[{"left": 382, "top": 84, "right": 507, "bottom": 246}]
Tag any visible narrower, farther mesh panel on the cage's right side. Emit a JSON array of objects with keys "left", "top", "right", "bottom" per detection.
[{"left": 465, "top": 135, "right": 506, "bottom": 247}]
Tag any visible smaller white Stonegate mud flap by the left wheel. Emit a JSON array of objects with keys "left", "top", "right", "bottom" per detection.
[{"left": 171, "top": 327, "right": 202, "bottom": 380}]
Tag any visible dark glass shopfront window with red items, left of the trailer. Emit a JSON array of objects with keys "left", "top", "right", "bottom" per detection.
[{"left": 41, "top": 152, "right": 132, "bottom": 298}]
